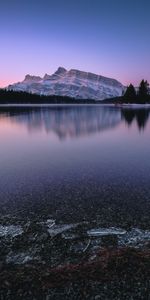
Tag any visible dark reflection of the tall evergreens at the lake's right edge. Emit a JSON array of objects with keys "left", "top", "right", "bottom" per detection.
[{"left": 121, "top": 109, "right": 150, "bottom": 130}]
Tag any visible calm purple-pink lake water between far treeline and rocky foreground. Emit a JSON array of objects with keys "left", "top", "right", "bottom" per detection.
[{"left": 0, "top": 105, "right": 150, "bottom": 227}]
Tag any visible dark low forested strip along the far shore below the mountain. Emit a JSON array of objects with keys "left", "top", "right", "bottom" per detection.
[{"left": 0, "top": 89, "right": 150, "bottom": 108}]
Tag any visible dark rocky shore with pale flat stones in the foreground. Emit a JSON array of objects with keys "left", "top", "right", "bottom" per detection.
[{"left": 0, "top": 216, "right": 150, "bottom": 300}]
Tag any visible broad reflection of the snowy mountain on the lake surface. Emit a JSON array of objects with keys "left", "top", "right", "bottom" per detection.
[{"left": 0, "top": 105, "right": 121, "bottom": 139}]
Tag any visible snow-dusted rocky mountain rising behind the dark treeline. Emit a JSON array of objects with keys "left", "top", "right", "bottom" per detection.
[{"left": 7, "top": 67, "right": 124, "bottom": 100}]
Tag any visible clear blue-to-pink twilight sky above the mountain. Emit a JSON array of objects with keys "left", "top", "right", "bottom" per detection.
[{"left": 0, "top": 0, "right": 150, "bottom": 87}]
